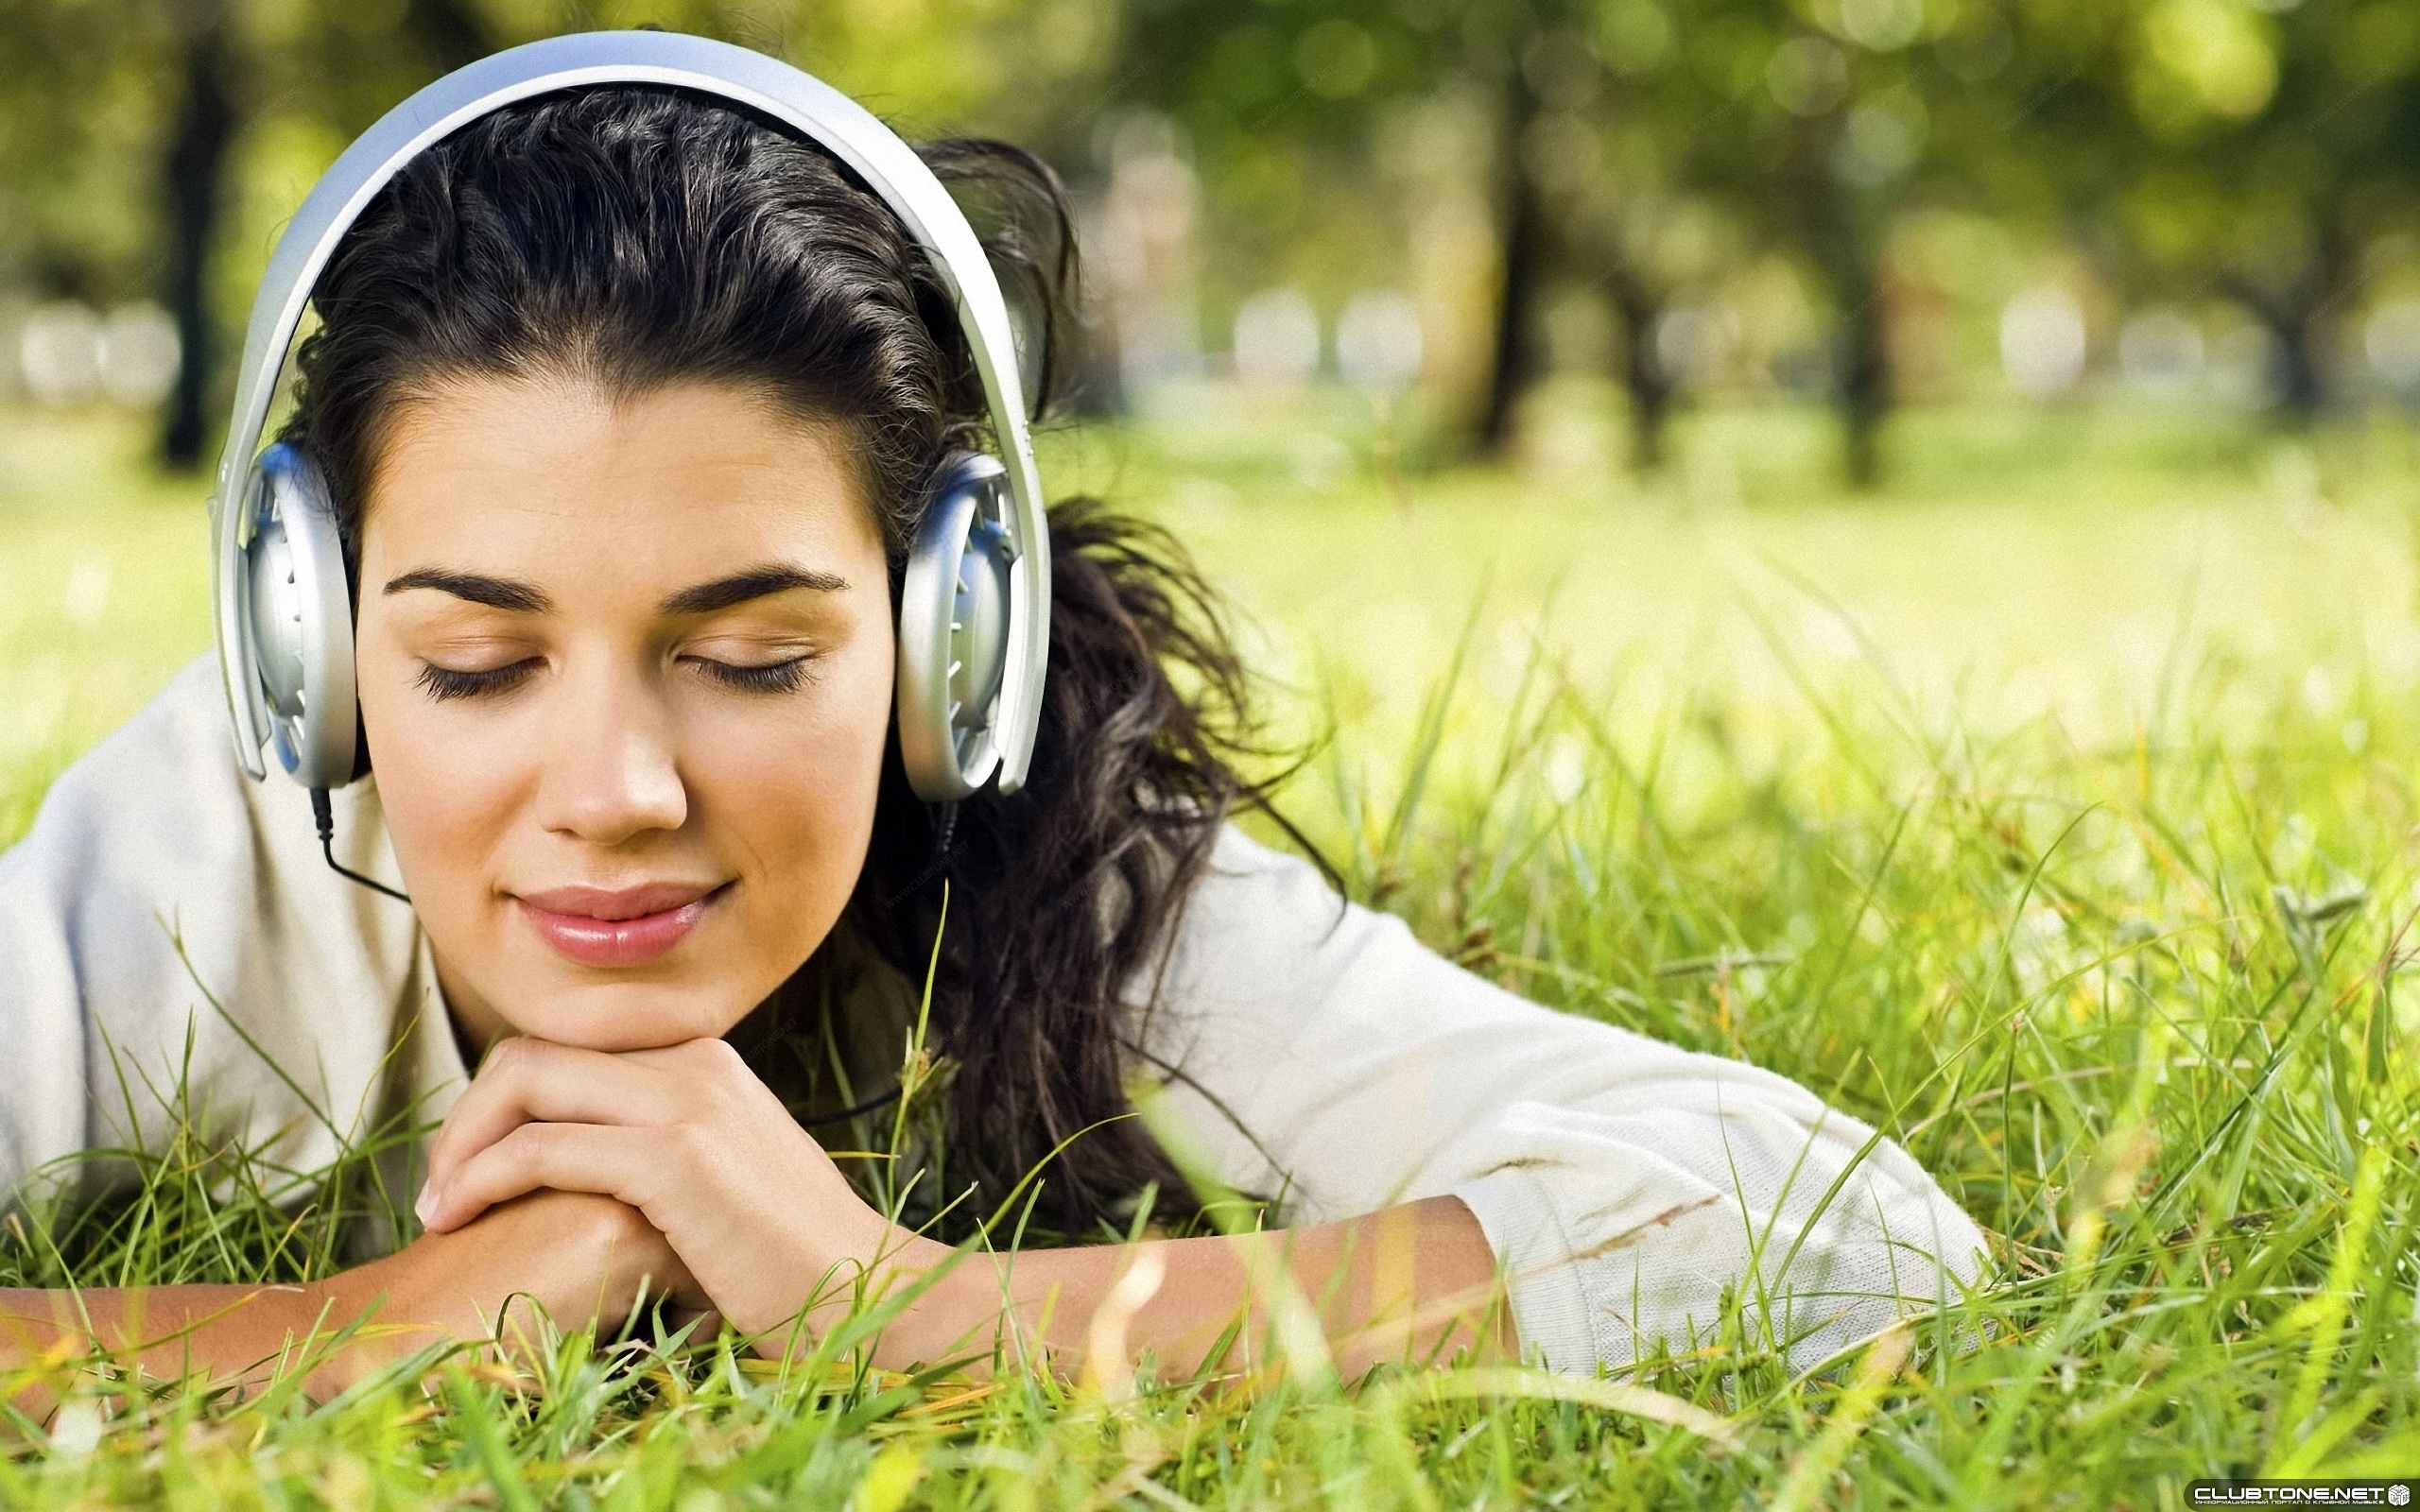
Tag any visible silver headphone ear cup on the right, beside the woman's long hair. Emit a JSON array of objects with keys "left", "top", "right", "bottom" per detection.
[{"left": 898, "top": 453, "right": 1011, "bottom": 803}]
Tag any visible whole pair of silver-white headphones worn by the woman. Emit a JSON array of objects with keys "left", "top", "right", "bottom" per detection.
[{"left": 211, "top": 31, "right": 1050, "bottom": 813}]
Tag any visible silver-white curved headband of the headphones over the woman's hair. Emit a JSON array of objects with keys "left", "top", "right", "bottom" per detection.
[{"left": 211, "top": 31, "right": 1050, "bottom": 794}]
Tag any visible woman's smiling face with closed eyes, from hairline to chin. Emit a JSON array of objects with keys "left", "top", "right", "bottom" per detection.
[{"left": 355, "top": 380, "right": 893, "bottom": 1050}]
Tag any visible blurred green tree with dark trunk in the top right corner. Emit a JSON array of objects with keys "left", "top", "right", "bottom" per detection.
[{"left": 2021, "top": 0, "right": 2420, "bottom": 419}]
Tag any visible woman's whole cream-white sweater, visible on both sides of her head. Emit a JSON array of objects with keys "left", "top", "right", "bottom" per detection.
[{"left": 0, "top": 661, "right": 1984, "bottom": 1372}]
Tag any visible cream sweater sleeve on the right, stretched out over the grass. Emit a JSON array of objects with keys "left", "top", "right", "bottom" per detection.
[{"left": 1142, "top": 830, "right": 1984, "bottom": 1372}]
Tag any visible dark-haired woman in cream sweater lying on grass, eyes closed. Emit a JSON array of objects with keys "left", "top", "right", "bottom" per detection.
[{"left": 0, "top": 41, "right": 1982, "bottom": 1383}]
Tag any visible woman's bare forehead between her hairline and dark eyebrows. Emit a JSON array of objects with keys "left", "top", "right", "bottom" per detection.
[{"left": 363, "top": 377, "right": 883, "bottom": 586}]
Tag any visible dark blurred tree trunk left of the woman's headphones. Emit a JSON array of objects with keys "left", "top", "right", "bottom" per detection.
[{"left": 160, "top": 5, "right": 234, "bottom": 470}]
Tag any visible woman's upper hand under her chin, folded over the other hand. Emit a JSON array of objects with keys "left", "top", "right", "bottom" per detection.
[{"left": 419, "top": 1036, "right": 951, "bottom": 1355}]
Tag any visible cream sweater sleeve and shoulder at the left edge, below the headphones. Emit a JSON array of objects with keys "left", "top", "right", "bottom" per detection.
[{"left": 0, "top": 658, "right": 450, "bottom": 1202}]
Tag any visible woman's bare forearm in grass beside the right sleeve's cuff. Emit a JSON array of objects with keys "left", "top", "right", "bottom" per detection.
[{"left": 813, "top": 1197, "right": 1517, "bottom": 1383}]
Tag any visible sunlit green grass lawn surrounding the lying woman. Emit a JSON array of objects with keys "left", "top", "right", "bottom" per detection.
[{"left": 0, "top": 402, "right": 2420, "bottom": 1512}]
